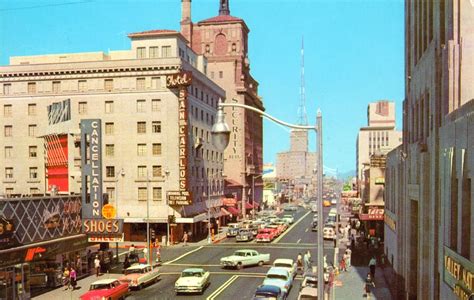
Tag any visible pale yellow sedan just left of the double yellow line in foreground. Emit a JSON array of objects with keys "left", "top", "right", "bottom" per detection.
[{"left": 174, "top": 268, "right": 210, "bottom": 295}]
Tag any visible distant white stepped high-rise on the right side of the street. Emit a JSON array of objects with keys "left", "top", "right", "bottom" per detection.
[{"left": 356, "top": 101, "right": 402, "bottom": 180}]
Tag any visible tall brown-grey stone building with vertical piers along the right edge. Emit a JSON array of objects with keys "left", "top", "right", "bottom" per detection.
[{"left": 384, "top": 1, "right": 474, "bottom": 299}]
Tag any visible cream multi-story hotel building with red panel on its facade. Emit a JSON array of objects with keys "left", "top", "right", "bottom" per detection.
[{"left": 0, "top": 30, "right": 225, "bottom": 240}]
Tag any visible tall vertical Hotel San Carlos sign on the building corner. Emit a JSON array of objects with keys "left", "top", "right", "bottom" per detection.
[{"left": 166, "top": 71, "right": 193, "bottom": 205}]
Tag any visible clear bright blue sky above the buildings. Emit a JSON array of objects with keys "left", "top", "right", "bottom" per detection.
[{"left": 0, "top": 0, "right": 404, "bottom": 172}]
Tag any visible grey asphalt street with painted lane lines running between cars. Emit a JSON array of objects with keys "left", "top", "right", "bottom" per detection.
[{"left": 127, "top": 208, "right": 334, "bottom": 300}]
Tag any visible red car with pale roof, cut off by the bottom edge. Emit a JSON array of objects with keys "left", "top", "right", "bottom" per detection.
[{"left": 80, "top": 279, "right": 128, "bottom": 300}]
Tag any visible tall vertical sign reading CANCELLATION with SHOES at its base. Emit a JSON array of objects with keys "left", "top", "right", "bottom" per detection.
[{"left": 81, "top": 119, "right": 123, "bottom": 235}]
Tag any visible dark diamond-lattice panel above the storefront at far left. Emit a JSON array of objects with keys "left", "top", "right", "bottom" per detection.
[{"left": 0, "top": 196, "right": 82, "bottom": 249}]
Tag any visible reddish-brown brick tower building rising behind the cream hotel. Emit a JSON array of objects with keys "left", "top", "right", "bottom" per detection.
[{"left": 181, "top": 0, "right": 264, "bottom": 211}]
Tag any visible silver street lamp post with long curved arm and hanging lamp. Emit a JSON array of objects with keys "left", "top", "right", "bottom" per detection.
[{"left": 211, "top": 99, "right": 324, "bottom": 299}]
